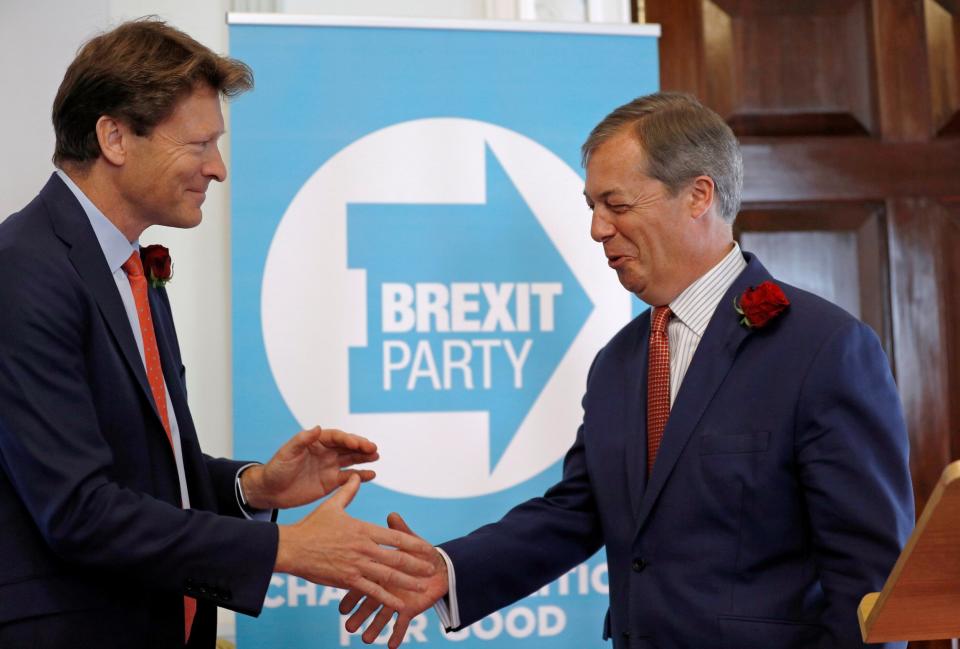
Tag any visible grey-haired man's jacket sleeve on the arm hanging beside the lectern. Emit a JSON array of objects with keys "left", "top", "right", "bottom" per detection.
[{"left": 796, "top": 321, "right": 914, "bottom": 649}]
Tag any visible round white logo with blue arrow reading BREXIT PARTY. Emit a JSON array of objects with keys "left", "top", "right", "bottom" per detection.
[{"left": 262, "top": 118, "right": 631, "bottom": 498}]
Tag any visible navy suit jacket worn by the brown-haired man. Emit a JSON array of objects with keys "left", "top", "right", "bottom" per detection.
[{"left": 0, "top": 175, "right": 277, "bottom": 647}]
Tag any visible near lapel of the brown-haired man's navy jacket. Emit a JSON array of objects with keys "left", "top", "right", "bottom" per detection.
[{"left": 40, "top": 175, "right": 166, "bottom": 428}]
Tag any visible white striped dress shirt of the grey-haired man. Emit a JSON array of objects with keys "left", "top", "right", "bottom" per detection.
[{"left": 667, "top": 243, "right": 747, "bottom": 408}]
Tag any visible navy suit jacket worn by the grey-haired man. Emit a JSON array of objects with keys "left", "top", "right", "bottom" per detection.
[{"left": 441, "top": 254, "right": 914, "bottom": 649}]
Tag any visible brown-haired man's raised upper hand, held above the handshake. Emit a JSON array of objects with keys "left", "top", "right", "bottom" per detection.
[{"left": 240, "top": 426, "right": 380, "bottom": 509}]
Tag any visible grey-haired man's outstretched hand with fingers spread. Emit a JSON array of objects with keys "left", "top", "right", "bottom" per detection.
[{"left": 340, "top": 514, "right": 449, "bottom": 649}]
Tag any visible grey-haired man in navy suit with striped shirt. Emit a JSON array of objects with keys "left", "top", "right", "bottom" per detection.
[{"left": 341, "top": 93, "right": 914, "bottom": 649}]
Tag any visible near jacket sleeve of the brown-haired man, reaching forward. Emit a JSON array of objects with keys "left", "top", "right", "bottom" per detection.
[{"left": 0, "top": 250, "right": 277, "bottom": 614}]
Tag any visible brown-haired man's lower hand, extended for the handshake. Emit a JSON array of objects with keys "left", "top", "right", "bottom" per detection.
[{"left": 275, "top": 475, "right": 436, "bottom": 609}]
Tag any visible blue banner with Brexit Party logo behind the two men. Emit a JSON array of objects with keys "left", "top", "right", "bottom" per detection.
[{"left": 230, "top": 16, "right": 658, "bottom": 649}]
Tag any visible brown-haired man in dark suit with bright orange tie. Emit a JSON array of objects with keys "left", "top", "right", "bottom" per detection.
[{"left": 0, "top": 20, "right": 432, "bottom": 649}]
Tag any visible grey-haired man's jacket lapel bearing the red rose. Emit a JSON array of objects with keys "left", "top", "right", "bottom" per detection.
[{"left": 634, "top": 253, "right": 770, "bottom": 532}]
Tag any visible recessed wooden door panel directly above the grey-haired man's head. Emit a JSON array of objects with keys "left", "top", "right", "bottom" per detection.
[{"left": 702, "top": 0, "right": 874, "bottom": 135}]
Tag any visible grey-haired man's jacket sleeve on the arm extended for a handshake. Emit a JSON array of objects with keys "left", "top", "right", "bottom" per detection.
[{"left": 440, "top": 354, "right": 603, "bottom": 630}]
